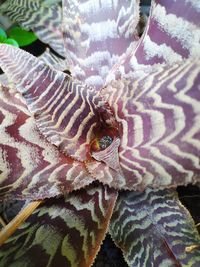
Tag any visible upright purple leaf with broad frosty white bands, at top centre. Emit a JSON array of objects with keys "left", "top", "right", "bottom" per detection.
[{"left": 63, "top": 0, "right": 139, "bottom": 88}]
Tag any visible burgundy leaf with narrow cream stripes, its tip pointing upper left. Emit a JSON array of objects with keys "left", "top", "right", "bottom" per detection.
[{"left": 0, "top": 44, "right": 115, "bottom": 161}]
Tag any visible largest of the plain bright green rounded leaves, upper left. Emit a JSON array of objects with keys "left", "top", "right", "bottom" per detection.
[{"left": 8, "top": 27, "right": 37, "bottom": 46}]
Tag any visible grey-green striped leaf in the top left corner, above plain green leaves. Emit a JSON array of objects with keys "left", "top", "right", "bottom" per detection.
[{"left": 0, "top": 0, "right": 65, "bottom": 57}]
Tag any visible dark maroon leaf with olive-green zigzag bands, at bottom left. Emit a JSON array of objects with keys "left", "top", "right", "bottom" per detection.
[{"left": 0, "top": 185, "right": 117, "bottom": 267}]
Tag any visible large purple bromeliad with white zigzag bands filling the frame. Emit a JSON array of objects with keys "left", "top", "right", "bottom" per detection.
[{"left": 0, "top": 0, "right": 200, "bottom": 267}]
